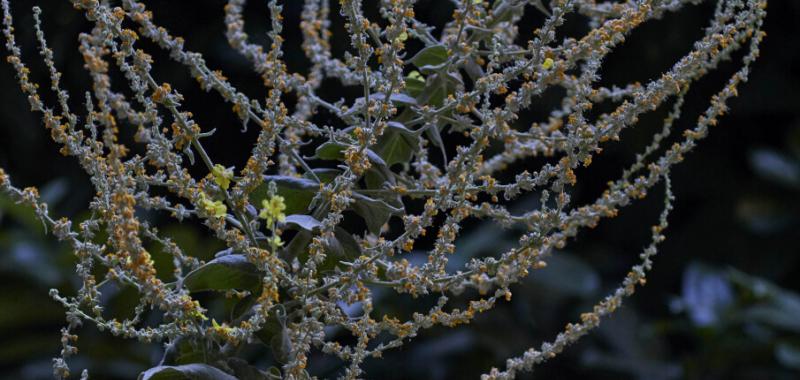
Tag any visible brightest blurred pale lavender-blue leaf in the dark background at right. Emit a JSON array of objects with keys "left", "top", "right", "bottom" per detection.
[{"left": 681, "top": 263, "right": 733, "bottom": 327}]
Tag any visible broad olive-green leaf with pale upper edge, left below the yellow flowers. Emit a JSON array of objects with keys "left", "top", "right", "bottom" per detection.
[{"left": 183, "top": 254, "right": 261, "bottom": 292}]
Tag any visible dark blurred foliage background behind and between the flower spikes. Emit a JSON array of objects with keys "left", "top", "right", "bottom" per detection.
[{"left": 0, "top": 0, "right": 800, "bottom": 379}]
